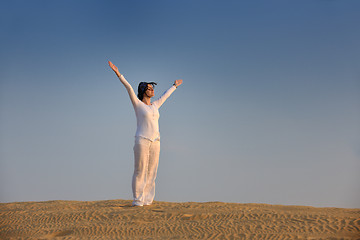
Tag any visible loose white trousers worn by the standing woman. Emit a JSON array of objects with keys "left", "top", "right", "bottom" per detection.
[{"left": 132, "top": 137, "right": 160, "bottom": 206}]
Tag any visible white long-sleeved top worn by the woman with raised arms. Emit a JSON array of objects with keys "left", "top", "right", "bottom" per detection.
[{"left": 119, "top": 75, "right": 176, "bottom": 141}]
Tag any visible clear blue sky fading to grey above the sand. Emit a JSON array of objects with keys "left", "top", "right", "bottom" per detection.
[{"left": 0, "top": 0, "right": 360, "bottom": 208}]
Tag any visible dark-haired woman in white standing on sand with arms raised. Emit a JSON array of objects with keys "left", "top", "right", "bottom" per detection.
[{"left": 109, "top": 61, "right": 182, "bottom": 206}]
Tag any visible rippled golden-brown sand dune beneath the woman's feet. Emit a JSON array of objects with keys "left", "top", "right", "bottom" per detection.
[{"left": 0, "top": 200, "right": 360, "bottom": 239}]
